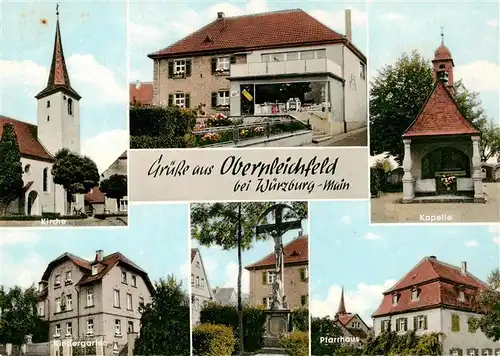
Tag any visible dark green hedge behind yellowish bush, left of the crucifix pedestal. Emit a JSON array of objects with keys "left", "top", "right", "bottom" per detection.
[{"left": 200, "top": 303, "right": 266, "bottom": 352}]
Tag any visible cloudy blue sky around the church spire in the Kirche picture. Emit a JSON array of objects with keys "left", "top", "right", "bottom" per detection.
[{"left": 0, "top": 0, "right": 128, "bottom": 172}]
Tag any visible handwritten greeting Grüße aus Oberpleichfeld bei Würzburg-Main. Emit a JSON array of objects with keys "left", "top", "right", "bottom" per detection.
[{"left": 148, "top": 154, "right": 350, "bottom": 194}]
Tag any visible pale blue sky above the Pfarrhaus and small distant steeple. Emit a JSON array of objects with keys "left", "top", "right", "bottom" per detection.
[{"left": 309, "top": 201, "right": 500, "bottom": 325}]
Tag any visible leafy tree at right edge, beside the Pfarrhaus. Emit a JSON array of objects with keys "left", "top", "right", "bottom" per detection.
[{"left": 476, "top": 268, "right": 500, "bottom": 342}]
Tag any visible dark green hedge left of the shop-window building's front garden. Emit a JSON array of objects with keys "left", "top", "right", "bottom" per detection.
[{"left": 130, "top": 107, "right": 196, "bottom": 148}]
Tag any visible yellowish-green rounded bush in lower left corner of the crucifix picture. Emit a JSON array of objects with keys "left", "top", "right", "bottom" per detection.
[{"left": 193, "top": 324, "right": 235, "bottom": 356}]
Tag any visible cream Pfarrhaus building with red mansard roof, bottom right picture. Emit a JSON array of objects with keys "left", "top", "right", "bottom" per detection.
[{"left": 373, "top": 256, "right": 500, "bottom": 356}]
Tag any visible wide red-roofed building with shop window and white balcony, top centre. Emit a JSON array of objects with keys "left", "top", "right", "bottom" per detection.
[{"left": 149, "top": 10, "right": 367, "bottom": 136}]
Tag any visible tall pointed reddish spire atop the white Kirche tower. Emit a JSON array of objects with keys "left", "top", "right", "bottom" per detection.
[{"left": 35, "top": 4, "right": 81, "bottom": 100}]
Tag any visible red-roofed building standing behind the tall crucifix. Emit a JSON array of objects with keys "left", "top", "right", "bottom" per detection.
[{"left": 245, "top": 236, "right": 309, "bottom": 310}]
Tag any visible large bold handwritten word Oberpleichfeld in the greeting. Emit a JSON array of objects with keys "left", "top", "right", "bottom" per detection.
[{"left": 220, "top": 156, "right": 339, "bottom": 178}]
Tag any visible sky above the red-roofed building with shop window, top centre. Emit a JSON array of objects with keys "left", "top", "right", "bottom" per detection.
[{"left": 129, "top": 0, "right": 368, "bottom": 82}]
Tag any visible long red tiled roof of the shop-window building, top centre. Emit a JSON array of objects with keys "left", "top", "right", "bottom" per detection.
[{"left": 148, "top": 9, "right": 366, "bottom": 63}]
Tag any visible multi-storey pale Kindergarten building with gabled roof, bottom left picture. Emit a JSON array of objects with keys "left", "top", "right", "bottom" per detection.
[{"left": 38, "top": 250, "right": 153, "bottom": 352}]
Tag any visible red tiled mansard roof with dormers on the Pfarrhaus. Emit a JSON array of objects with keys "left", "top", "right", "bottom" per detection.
[{"left": 373, "top": 256, "right": 489, "bottom": 317}]
